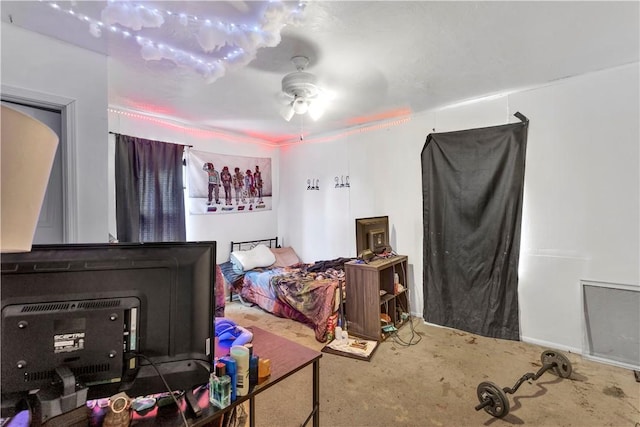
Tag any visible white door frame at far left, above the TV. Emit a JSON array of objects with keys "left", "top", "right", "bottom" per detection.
[{"left": 0, "top": 84, "right": 78, "bottom": 243}]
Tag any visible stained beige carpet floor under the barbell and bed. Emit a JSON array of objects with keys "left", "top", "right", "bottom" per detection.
[{"left": 226, "top": 302, "right": 640, "bottom": 427}]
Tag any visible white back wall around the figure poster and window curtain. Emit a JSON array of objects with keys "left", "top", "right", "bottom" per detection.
[{"left": 109, "top": 110, "right": 280, "bottom": 263}]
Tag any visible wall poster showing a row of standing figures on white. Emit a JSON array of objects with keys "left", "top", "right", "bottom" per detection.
[{"left": 187, "top": 150, "right": 273, "bottom": 215}]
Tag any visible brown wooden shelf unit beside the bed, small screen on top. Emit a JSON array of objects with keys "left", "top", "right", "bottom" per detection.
[{"left": 344, "top": 255, "right": 409, "bottom": 341}]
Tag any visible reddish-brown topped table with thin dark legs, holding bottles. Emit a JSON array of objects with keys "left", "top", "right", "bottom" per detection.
[{"left": 125, "top": 326, "right": 322, "bottom": 427}]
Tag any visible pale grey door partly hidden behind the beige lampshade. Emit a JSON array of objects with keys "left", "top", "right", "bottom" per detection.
[{"left": 2, "top": 101, "right": 64, "bottom": 244}]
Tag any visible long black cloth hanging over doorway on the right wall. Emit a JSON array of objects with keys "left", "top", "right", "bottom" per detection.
[{"left": 422, "top": 113, "right": 528, "bottom": 340}]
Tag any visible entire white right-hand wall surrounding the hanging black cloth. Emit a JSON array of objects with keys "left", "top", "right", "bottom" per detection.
[{"left": 278, "top": 64, "right": 640, "bottom": 352}]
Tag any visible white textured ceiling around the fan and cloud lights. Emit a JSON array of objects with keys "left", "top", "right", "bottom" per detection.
[{"left": 0, "top": 1, "right": 640, "bottom": 142}]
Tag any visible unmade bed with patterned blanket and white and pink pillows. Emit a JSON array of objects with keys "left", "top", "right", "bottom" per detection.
[{"left": 220, "top": 238, "right": 351, "bottom": 342}]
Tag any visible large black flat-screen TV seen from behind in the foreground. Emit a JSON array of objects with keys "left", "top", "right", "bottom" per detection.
[{"left": 0, "top": 242, "right": 216, "bottom": 422}]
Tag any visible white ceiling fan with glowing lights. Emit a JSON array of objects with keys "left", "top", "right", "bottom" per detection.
[{"left": 280, "top": 56, "right": 329, "bottom": 121}]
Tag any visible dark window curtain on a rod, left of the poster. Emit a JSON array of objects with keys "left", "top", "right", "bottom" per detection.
[{"left": 115, "top": 135, "right": 186, "bottom": 242}]
